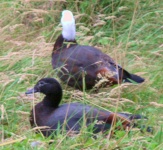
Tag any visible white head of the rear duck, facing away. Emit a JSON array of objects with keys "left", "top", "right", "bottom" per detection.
[{"left": 61, "top": 10, "right": 76, "bottom": 41}]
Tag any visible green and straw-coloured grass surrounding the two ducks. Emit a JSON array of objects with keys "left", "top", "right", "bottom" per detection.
[{"left": 0, "top": 0, "right": 163, "bottom": 150}]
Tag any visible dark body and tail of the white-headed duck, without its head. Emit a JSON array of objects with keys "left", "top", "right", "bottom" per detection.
[{"left": 52, "top": 35, "right": 144, "bottom": 89}]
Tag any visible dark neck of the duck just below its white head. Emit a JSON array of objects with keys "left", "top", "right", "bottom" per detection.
[{"left": 53, "top": 34, "right": 77, "bottom": 52}]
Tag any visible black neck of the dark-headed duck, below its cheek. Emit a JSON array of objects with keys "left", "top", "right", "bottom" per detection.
[{"left": 43, "top": 89, "right": 62, "bottom": 108}]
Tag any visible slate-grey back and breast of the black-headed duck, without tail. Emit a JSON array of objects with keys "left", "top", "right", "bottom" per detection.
[{"left": 31, "top": 103, "right": 111, "bottom": 136}]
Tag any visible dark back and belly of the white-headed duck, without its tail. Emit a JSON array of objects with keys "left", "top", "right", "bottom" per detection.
[{"left": 52, "top": 44, "right": 117, "bottom": 89}]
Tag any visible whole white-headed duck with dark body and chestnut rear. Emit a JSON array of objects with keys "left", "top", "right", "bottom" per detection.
[{"left": 51, "top": 10, "right": 144, "bottom": 90}]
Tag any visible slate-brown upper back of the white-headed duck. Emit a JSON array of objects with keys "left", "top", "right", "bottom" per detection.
[{"left": 52, "top": 44, "right": 114, "bottom": 69}]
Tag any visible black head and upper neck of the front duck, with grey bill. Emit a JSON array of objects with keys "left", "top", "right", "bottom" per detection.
[{"left": 25, "top": 78, "right": 62, "bottom": 107}]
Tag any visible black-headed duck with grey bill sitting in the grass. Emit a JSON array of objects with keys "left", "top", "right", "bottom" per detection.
[{"left": 26, "top": 78, "right": 148, "bottom": 136}]
